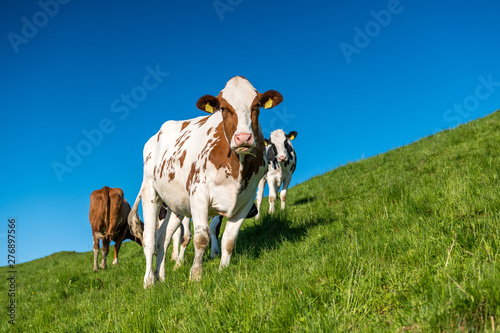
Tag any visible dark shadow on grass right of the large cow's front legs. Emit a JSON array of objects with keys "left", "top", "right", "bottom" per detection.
[{"left": 236, "top": 212, "right": 334, "bottom": 258}]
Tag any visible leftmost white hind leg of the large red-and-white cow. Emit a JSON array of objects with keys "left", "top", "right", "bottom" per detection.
[{"left": 142, "top": 185, "right": 161, "bottom": 288}]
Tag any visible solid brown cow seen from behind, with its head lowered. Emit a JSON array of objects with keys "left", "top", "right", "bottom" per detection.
[{"left": 89, "top": 186, "right": 144, "bottom": 272}]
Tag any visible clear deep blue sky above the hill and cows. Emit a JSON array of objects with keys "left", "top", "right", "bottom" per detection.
[{"left": 0, "top": 0, "right": 500, "bottom": 267}]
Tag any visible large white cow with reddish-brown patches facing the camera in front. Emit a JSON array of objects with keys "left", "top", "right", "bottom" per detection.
[{"left": 129, "top": 76, "right": 283, "bottom": 288}]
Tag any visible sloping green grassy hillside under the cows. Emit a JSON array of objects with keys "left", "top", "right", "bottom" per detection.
[{"left": 0, "top": 112, "right": 500, "bottom": 332}]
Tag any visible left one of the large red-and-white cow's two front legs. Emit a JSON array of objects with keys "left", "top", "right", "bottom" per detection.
[{"left": 189, "top": 196, "right": 210, "bottom": 281}]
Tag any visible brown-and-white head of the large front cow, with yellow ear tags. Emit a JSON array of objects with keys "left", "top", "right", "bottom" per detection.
[{"left": 196, "top": 76, "right": 283, "bottom": 154}]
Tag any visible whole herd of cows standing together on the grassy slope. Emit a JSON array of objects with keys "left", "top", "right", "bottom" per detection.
[{"left": 89, "top": 76, "right": 297, "bottom": 288}]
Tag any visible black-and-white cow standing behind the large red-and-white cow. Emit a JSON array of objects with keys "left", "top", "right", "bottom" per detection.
[{"left": 255, "top": 129, "right": 297, "bottom": 219}]
